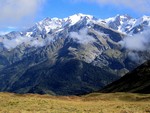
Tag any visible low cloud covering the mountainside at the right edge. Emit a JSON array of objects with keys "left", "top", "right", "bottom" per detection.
[{"left": 119, "top": 30, "right": 150, "bottom": 63}]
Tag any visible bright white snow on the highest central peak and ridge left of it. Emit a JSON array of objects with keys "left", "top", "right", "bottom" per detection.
[{"left": 25, "top": 13, "right": 95, "bottom": 33}]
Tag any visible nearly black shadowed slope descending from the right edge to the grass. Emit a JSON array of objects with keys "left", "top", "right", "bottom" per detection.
[{"left": 101, "top": 61, "right": 150, "bottom": 93}]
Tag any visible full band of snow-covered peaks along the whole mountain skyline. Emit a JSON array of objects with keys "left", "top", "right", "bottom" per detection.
[{"left": 1, "top": 13, "right": 150, "bottom": 44}]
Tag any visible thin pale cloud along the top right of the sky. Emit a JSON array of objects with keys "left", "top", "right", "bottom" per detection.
[{"left": 72, "top": 0, "right": 150, "bottom": 13}]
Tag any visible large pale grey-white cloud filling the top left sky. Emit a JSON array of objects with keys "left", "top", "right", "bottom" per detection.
[{"left": 0, "top": 0, "right": 45, "bottom": 27}]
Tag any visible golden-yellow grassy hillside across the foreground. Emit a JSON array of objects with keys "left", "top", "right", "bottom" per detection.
[{"left": 0, "top": 93, "right": 150, "bottom": 113}]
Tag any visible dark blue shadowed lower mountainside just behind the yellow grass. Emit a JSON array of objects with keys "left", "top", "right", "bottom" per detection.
[{"left": 0, "top": 60, "right": 118, "bottom": 95}]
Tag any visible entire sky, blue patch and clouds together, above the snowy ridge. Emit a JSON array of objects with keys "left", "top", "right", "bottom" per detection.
[{"left": 0, "top": 0, "right": 150, "bottom": 33}]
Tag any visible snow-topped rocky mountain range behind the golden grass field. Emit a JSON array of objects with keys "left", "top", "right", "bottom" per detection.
[{"left": 0, "top": 14, "right": 150, "bottom": 95}]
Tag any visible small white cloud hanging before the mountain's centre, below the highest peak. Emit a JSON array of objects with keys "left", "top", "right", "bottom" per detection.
[{"left": 70, "top": 28, "right": 95, "bottom": 44}]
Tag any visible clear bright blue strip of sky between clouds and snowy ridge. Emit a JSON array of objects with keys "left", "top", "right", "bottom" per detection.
[{"left": 38, "top": 0, "right": 148, "bottom": 19}]
